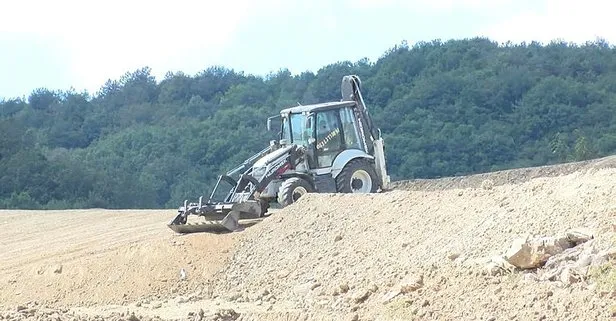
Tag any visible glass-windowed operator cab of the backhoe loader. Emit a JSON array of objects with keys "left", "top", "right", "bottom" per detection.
[{"left": 270, "top": 101, "right": 367, "bottom": 169}]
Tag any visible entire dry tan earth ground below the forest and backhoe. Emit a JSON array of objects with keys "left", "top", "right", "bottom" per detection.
[{"left": 0, "top": 157, "right": 616, "bottom": 320}]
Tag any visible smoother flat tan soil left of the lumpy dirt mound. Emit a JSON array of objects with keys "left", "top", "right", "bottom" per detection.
[{"left": 0, "top": 209, "right": 239, "bottom": 307}]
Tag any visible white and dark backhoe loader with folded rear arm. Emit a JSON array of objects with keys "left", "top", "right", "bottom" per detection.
[{"left": 168, "top": 75, "right": 390, "bottom": 233}]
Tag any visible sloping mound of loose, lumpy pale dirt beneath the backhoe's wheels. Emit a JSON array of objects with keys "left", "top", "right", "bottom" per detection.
[{"left": 211, "top": 159, "right": 616, "bottom": 320}]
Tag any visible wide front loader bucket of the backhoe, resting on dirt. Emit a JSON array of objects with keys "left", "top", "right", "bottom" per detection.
[{"left": 167, "top": 201, "right": 263, "bottom": 234}]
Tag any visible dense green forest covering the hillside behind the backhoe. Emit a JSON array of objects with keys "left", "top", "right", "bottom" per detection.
[{"left": 0, "top": 38, "right": 616, "bottom": 209}]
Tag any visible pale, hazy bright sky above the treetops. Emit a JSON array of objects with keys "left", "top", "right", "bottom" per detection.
[{"left": 0, "top": 0, "right": 616, "bottom": 100}]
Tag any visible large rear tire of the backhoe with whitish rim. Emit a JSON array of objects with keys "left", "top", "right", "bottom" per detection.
[{"left": 336, "top": 158, "right": 379, "bottom": 193}]
